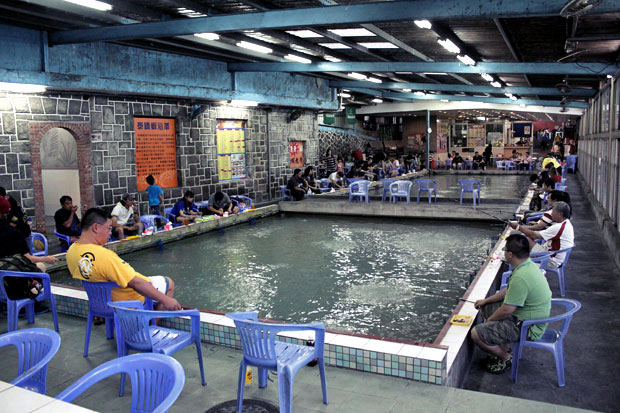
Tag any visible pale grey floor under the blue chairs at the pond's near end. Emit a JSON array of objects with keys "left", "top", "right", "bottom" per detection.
[{"left": 0, "top": 313, "right": 592, "bottom": 413}]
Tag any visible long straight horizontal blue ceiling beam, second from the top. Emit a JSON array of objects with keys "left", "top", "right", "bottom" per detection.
[{"left": 228, "top": 62, "right": 618, "bottom": 75}]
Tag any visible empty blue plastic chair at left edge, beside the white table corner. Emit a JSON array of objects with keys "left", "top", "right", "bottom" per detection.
[{"left": 0, "top": 328, "right": 60, "bottom": 394}]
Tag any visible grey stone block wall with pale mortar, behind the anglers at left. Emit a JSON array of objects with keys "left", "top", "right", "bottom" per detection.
[{"left": 0, "top": 94, "right": 320, "bottom": 231}]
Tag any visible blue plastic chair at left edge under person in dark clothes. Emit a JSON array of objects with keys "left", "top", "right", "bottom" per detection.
[{"left": 0, "top": 271, "right": 58, "bottom": 332}]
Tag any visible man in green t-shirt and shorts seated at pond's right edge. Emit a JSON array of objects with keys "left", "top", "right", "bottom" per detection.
[{"left": 471, "top": 234, "right": 551, "bottom": 374}]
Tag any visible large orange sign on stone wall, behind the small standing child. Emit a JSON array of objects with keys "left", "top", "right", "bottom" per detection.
[{"left": 133, "top": 117, "right": 178, "bottom": 191}]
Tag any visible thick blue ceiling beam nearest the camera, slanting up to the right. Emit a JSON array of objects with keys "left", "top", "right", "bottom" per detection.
[{"left": 49, "top": 0, "right": 620, "bottom": 44}]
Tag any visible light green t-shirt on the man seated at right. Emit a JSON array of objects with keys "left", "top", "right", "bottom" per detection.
[{"left": 504, "top": 259, "right": 551, "bottom": 340}]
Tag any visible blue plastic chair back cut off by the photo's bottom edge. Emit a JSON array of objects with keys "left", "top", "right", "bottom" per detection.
[{"left": 56, "top": 354, "right": 185, "bottom": 413}]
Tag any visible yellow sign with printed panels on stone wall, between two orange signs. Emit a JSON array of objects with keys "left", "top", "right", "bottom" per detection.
[{"left": 216, "top": 120, "right": 248, "bottom": 181}]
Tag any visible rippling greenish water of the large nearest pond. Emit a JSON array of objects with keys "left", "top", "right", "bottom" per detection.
[{"left": 53, "top": 216, "right": 501, "bottom": 341}]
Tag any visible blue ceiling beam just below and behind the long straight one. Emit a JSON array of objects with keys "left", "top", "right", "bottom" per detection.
[{"left": 329, "top": 80, "right": 596, "bottom": 97}]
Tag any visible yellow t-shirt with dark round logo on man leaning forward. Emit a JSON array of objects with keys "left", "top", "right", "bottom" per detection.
[{"left": 67, "top": 242, "right": 151, "bottom": 302}]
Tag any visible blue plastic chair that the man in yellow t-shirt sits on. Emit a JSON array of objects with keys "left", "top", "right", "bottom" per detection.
[{"left": 82, "top": 281, "right": 153, "bottom": 357}]
